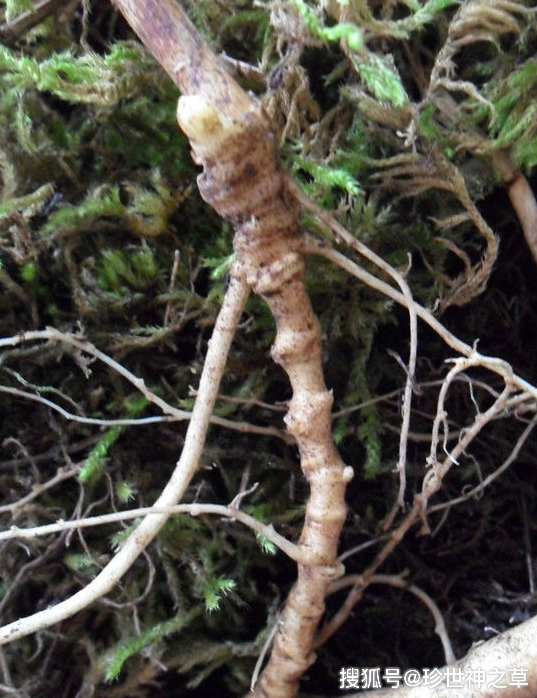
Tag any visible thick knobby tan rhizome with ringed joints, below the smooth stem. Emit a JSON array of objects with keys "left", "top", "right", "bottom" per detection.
[{"left": 178, "top": 95, "right": 352, "bottom": 698}]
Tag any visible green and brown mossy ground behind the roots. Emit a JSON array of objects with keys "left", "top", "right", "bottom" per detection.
[{"left": 0, "top": 0, "right": 537, "bottom": 698}]
